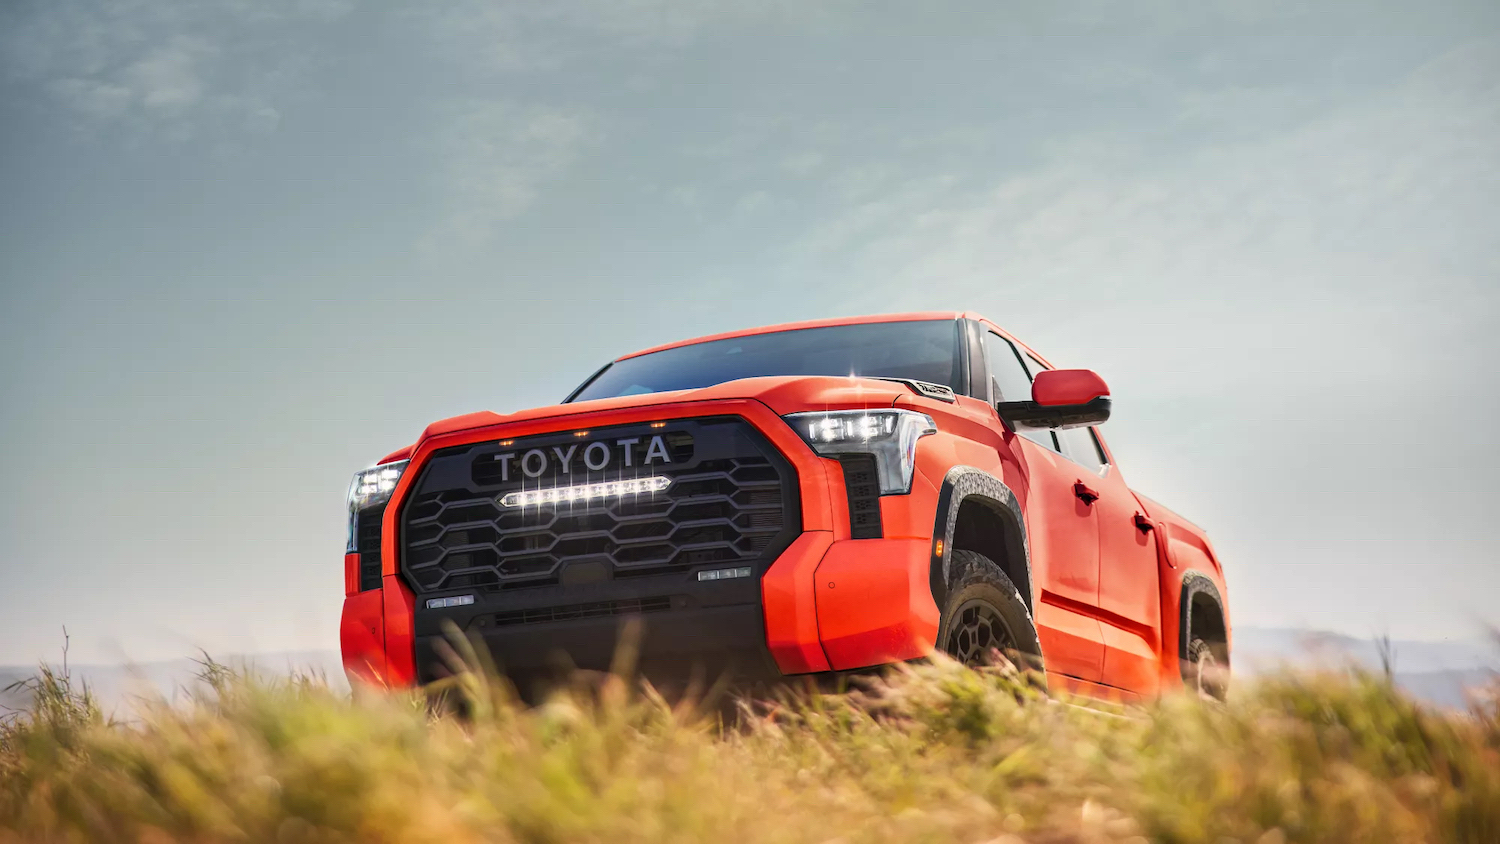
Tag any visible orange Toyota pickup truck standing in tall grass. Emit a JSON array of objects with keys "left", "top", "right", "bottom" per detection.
[{"left": 341, "top": 313, "right": 1230, "bottom": 700}]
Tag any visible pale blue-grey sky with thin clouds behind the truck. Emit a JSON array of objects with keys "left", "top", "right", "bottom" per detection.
[{"left": 0, "top": 0, "right": 1500, "bottom": 664}]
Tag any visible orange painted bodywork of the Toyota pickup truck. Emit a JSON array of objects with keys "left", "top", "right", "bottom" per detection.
[{"left": 341, "top": 312, "right": 1227, "bottom": 700}]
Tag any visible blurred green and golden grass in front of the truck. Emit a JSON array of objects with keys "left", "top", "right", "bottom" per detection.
[{"left": 0, "top": 650, "right": 1500, "bottom": 844}]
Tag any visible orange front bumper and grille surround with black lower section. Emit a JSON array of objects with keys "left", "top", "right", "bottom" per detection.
[{"left": 341, "top": 400, "right": 939, "bottom": 685}]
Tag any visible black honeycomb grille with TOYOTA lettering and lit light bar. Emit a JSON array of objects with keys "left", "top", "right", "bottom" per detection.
[{"left": 401, "top": 418, "right": 801, "bottom": 594}]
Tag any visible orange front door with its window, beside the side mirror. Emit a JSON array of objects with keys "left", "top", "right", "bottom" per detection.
[{"left": 984, "top": 331, "right": 1104, "bottom": 682}]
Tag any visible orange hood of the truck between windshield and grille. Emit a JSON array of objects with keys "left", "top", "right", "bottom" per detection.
[{"left": 419, "top": 375, "right": 911, "bottom": 442}]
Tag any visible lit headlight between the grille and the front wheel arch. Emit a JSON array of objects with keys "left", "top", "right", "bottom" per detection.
[{"left": 786, "top": 411, "right": 938, "bottom": 495}]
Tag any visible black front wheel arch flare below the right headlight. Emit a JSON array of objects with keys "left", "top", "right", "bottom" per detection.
[{"left": 930, "top": 466, "right": 1037, "bottom": 613}]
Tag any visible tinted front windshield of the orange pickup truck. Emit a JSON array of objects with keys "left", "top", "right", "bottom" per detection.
[{"left": 569, "top": 319, "right": 959, "bottom": 402}]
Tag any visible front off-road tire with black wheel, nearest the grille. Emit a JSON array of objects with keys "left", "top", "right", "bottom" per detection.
[{"left": 938, "top": 550, "right": 1043, "bottom": 670}]
